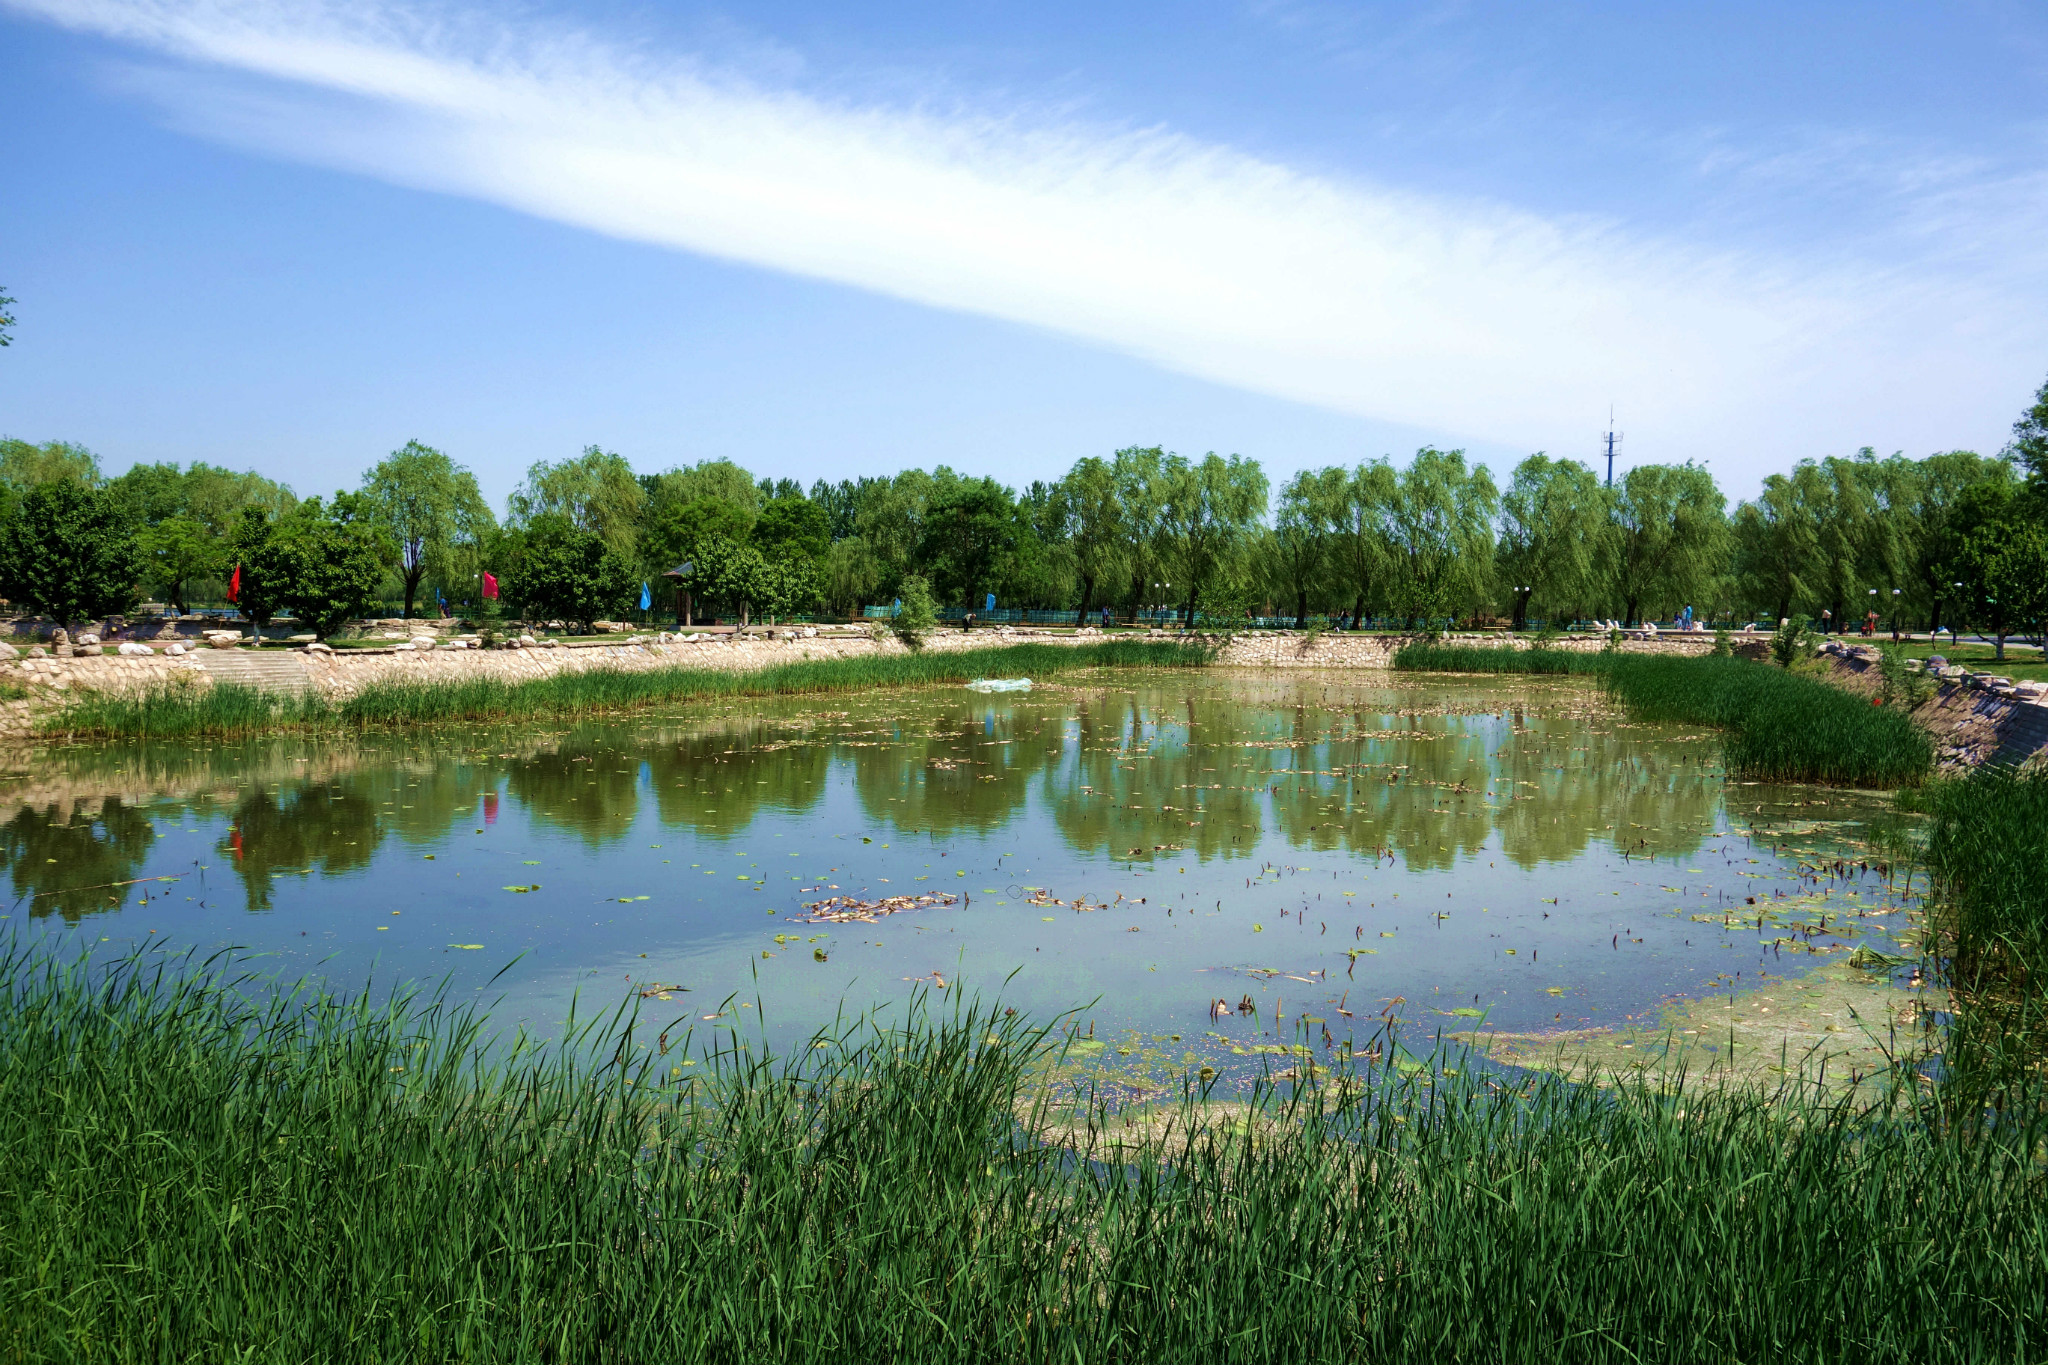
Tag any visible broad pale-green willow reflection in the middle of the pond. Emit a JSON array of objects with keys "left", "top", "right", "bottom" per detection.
[{"left": 1047, "top": 692, "right": 1266, "bottom": 862}]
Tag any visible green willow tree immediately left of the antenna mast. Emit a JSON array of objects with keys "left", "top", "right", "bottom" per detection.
[{"left": 1493, "top": 450, "right": 1608, "bottom": 630}]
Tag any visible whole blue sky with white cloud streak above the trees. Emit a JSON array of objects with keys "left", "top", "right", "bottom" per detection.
[{"left": 0, "top": 0, "right": 2048, "bottom": 499}]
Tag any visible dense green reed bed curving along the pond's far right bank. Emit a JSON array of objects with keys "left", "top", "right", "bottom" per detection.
[{"left": 1395, "top": 645, "right": 1933, "bottom": 788}]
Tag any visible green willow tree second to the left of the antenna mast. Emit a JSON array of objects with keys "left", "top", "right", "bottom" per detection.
[{"left": 1389, "top": 446, "right": 1499, "bottom": 622}]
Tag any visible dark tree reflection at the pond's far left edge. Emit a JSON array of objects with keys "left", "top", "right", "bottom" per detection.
[{"left": 0, "top": 796, "right": 156, "bottom": 923}]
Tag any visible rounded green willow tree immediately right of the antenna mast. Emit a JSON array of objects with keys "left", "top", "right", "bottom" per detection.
[{"left": 1606, "top": 463, "right": 1729, "bottom": 622}]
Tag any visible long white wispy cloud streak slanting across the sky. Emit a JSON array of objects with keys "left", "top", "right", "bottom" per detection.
[{"left": 0, "top": 0, "right": 2042, "bottom": 464}]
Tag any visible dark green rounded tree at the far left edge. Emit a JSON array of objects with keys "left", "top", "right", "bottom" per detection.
[{"left": 0, "top": 479, "right": 141, "bottom": 626}]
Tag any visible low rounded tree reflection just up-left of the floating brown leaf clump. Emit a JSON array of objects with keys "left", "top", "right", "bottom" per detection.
[{"left": 645, "top": 720, "right": 831, "bottom": 839}]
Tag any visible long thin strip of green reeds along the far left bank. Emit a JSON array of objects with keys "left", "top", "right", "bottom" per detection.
[{"left": 45, "top": 641, "right": 1206, "bottom": 739}]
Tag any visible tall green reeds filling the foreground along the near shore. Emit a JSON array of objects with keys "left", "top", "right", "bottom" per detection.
[{"left": 0, "top": 952, "right": 2048, "bottom": 1365}]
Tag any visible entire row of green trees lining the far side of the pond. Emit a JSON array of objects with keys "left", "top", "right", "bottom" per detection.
[{"left": 0, "top": 385, "right": 2048, "bottom": 634}]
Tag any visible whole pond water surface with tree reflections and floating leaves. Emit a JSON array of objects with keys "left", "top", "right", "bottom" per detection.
[{"left": 0, "top": 671, "right": 1915, "bottom": 1070}]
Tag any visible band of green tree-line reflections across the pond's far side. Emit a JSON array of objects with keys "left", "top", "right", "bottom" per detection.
[{"left": 0, "top": 673, "right": 1722, "bottom": 921}]
